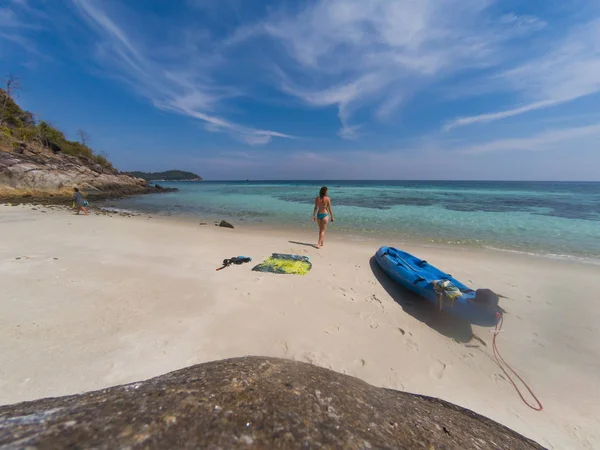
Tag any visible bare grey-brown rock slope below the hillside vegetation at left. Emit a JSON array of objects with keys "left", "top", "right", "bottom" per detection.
[{"left": 0, "top": 148, "right": 172, "bottom": 198}]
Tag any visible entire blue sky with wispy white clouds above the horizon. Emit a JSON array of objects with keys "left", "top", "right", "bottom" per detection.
[{"left": 0, "top": 0, "right": 600, "bottom": 180}]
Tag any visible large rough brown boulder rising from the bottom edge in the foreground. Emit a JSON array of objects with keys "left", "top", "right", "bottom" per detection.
[{"left": 0, "top": 357, "right": 541, "bottom": 449}]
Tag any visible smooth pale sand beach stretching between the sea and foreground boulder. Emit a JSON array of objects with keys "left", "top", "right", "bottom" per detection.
[{"left": 0, "top": 205, "right": 600, "bottom": 449}]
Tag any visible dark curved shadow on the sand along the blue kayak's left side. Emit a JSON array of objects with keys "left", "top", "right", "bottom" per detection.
[{"left": 369, "top": 256, "right": 473, "bottom": 343}]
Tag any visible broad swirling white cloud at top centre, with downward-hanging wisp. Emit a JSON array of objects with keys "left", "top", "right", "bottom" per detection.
[{"left": 226, "top": 0, "right": 545, "bottom": 138}]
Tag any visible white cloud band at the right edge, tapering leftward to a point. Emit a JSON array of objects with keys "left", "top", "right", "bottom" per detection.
[{"left": 444, "top": 19, "right": 600, "bottom": 130}]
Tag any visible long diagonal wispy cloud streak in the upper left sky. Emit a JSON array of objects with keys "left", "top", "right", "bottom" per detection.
[{"left": 72, "top": 0, "right": 292, "bottom": 145}]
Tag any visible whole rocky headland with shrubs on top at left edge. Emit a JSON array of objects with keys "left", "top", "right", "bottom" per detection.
[{"left": 0, "top": 89, "right": 169, "bottom": 200}]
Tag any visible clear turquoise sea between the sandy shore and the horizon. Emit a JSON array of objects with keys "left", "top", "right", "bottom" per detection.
[{"left": 107, "top": 181, "right": 600, "bottom": 262}]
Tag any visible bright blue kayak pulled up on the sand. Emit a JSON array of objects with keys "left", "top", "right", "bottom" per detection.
[{"left": 375, "top": 247, "right": 502, "bottom": 326}]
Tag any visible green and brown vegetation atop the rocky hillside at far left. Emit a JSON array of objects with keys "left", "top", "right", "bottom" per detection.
[{"left": 0, "top": 77, "right": 114, "bottom": 169}]
